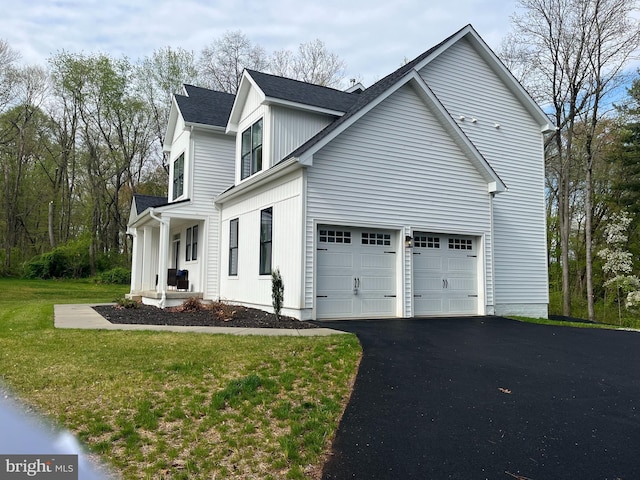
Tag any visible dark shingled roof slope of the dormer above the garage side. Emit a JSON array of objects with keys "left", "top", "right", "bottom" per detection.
[{"left": 247, "top": 70, "right": 359, "bottom": 112}]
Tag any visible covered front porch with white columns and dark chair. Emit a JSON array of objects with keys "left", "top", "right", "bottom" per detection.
[{"left": 127, "top": 204, "right": 206, "bottom": 308}]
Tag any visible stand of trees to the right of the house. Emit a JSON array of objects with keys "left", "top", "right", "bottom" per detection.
[{"left": 501, "top": 0, "right": 640, "bottom": 320}]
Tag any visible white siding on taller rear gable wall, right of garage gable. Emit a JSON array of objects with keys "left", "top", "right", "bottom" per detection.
[{"left": 421, "top": 40, "right": 548, "bottom": 314}]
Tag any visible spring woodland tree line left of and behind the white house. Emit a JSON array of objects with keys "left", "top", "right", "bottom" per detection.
[{"left": 0, "top": 31, "right": 345, "bottom": 276}]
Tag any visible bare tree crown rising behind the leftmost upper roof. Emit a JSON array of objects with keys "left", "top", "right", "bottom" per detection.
[{"left": 200, "top": 30, "right": 268, "bottom": 93}]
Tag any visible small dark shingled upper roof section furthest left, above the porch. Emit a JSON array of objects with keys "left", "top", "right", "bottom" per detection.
[{"left": 175, "top": 85, "right": 235, "bottom": 127}]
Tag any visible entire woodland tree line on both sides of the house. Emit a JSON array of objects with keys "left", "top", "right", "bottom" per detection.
[{"left": 0, "top": 0, "right": 640, "bottom": 319}]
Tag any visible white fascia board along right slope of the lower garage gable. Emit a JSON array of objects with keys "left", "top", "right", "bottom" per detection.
[{"left": 407, "top": 70, "right": 507, "bottom": 193}]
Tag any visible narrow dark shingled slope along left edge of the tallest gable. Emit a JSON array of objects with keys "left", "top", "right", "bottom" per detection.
[{"left": 281, "top": 25, "right": 468, "bottom": 161}]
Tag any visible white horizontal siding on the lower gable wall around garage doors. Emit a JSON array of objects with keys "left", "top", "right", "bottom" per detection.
[{"left": 305, "top": 82, "right": 492, "bottom": 315}]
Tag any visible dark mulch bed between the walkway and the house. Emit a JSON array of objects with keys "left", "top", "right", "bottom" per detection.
[{"left": 93, "top": 304, "right": 318, "bottom": 329}]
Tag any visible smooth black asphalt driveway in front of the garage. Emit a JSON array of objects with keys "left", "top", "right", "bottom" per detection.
[{"left": 319, "top": 317, "right": 640, "bottom": 480}]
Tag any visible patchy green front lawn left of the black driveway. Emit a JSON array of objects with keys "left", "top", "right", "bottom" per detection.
[{"left": 0, "top": 279, "right": 361, "bottom": 479}]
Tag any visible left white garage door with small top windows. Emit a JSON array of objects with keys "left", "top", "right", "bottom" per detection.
[{"left": 316, "top": 226, "right": 398, "bottom": 318}]
